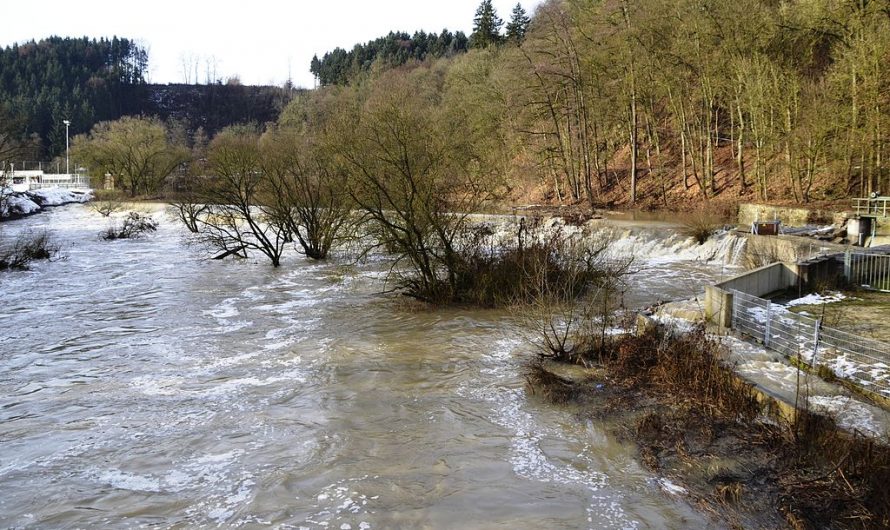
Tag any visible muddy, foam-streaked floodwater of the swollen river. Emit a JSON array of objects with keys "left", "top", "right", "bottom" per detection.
[{"left": 0, "top": 205, "right": 744, "bottom": 529}]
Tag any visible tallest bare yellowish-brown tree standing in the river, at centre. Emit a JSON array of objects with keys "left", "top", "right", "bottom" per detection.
[{"left": 338, "top": 69, "right": 500, "bottom": 303}]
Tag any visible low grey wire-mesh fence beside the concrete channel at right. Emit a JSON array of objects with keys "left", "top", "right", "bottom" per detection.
[{"left": 732, "top": 291, "right": 890, "bottom": 398}]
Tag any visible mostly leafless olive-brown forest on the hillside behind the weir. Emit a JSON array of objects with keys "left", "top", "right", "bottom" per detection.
[{"left": 0, "top": 0, "right": 890, "bottom": 208}]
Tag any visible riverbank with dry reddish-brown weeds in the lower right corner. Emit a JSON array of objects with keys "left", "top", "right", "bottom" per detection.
[{"left": 527, "top": 328, "right": 890, "bottom": 529}]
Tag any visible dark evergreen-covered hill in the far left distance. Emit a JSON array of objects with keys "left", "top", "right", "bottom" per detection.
[{"left": 0, "top": 37, "right": 295, "bottom": 164}]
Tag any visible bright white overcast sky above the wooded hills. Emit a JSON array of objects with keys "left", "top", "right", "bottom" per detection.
[{"left": 0, "top": 0, "right": 540, "bottom": 87}]
